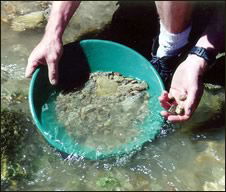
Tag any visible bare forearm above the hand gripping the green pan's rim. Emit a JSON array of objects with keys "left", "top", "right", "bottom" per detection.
[{"left": 45, "top": 1, "right": 80, "bottom": 38}]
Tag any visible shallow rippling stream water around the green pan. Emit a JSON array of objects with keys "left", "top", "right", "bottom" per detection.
[{"left": 1, "top": 0, "right": 225, "bottom": 191}]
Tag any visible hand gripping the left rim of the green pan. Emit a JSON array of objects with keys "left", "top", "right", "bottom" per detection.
[{"left": 25, "top": 34, "right": 63, "bottom": 85}]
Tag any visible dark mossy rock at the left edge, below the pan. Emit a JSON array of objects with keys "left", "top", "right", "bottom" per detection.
[{"left": 1, "top": 109, "right": 29, "bottom": 190}]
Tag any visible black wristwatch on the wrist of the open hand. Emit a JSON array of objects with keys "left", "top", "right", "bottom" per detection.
[{"left": 189, "top": 46, "right": 217, "bottom": 65}]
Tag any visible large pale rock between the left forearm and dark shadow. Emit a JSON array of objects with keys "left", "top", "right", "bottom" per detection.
[{"left": 63, "top": 1, "right": 118, "bottom": 43}]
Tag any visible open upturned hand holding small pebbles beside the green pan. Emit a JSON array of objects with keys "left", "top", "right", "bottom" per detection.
[{"left": 159, "top": 55, "right": 207, "bottom": 123}]
